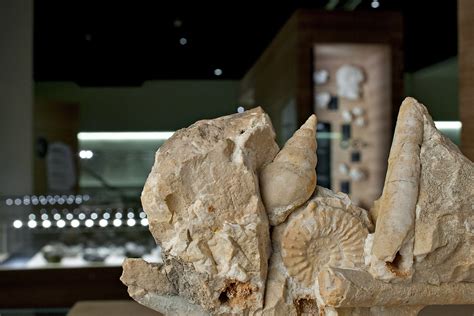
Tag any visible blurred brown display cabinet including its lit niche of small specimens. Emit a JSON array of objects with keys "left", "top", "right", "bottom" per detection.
[{"left": 240, "top": 10, "right": 403, "bottom": 207}]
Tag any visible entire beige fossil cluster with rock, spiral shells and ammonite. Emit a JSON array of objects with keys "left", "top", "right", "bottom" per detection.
[{"left": 121, "top": 98, "right": 474, "bottom": 316}]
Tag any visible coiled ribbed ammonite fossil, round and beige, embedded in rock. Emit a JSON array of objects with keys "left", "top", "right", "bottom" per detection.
[{"left": 282, "top": 202, "right": 368, "bottom": 287}]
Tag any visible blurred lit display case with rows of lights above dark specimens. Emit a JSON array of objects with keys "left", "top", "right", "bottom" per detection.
[{"left": 0, "top": 194, "right": 160, "bottom": 269}]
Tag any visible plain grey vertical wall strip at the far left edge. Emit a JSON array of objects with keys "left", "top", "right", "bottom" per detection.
[{"left": 0, "top": 0, "right": 33, "bottom": 195}]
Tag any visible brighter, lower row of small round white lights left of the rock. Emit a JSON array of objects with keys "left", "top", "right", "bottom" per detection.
[{"left": 13, "top": 212, "right": 148, "bottom": 229}]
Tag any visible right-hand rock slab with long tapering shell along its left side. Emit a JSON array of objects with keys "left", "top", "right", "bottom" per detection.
[{"left": 366, "top": 98, "right": 474, "bottom": 284}]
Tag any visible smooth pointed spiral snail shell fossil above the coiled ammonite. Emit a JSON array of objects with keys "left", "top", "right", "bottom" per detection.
[{"left": 260, "top": 114, "right": 317, "bottom": 226}]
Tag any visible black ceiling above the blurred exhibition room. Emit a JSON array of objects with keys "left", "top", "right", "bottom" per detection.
[{"left": 34, "top": 0, "right": 457, "bottom": 85}]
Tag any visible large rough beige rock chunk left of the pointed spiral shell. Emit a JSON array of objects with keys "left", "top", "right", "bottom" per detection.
[{"left": 125, "top": 108, "right": 278, "bottom": 313}]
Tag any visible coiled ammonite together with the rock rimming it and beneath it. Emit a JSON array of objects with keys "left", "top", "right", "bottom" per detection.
[{"left": 263, "top": 187, "right": 374, "bottom": 315}]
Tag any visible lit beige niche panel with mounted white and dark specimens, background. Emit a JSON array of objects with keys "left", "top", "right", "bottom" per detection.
[{"left": 313, "top": 44, "right": 391, "bottom": 208}]
